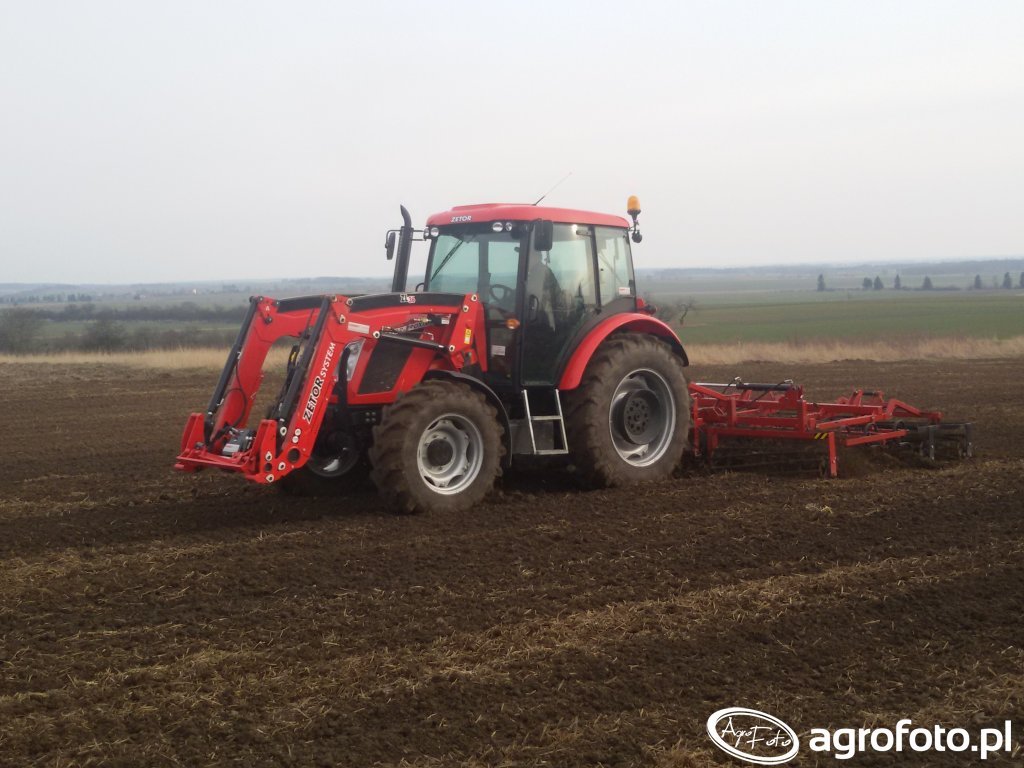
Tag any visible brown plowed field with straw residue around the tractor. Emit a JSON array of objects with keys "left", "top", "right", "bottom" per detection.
[{"left": 0, "top": 360, "right": 1024, "bottom": 766}]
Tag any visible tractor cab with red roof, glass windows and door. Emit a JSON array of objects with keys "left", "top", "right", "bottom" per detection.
[{"left": 417, "top": 205, "right": 637, "bottom": 390}]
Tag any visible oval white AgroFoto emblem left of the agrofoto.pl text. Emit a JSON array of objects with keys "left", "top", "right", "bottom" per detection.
[{"left": 708, "top": 707, "right": 800, "bottom": 765}]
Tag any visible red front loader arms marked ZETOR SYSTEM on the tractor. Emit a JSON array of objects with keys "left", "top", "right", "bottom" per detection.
[{"left": 175, "top": 294, "right": 486, "bottom": 482}]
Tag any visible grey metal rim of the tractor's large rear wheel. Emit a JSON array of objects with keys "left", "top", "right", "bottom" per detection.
[{"left": 608, "top": 368, "right": 676, "bottom": 467}]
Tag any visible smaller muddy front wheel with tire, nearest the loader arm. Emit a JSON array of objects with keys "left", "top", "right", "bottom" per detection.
[{"left": 370, "top": 379, "right": 505, "bottom": 513}]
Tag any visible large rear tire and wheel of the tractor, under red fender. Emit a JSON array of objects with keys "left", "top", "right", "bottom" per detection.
[{"left": 565, "top": 334, "right": 690, "bottom": 487}]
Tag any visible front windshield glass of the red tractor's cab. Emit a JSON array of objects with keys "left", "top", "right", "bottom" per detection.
[{"left": 426, "top": 224, "right": 520, "bottom": 301}]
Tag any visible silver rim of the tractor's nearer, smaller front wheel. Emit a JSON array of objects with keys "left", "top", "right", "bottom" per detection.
[{"left": 416, "top": 414, "right": 483, "bottom": 496}]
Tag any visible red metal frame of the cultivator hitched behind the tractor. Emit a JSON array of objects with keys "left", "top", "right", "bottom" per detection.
[{"left": 689, "top": 384, "right": 942, "bottom": 477}]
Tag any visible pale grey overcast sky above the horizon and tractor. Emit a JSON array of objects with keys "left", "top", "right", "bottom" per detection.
[{"left": 0, "top": 0, "right": 1024, "bottom": 283}]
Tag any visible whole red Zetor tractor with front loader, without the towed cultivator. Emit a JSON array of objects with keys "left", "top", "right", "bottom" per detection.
[{"left": 175, "top": 198, "right": 691, "bottom": 512}]
